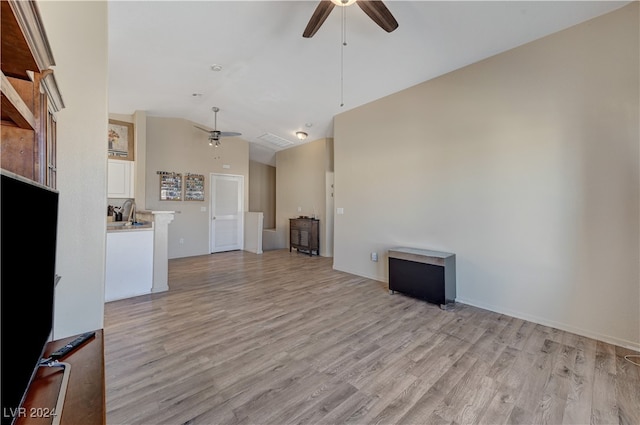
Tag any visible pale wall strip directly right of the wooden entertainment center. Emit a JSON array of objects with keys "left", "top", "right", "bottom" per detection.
[{"left": 38, "top": 1, "right": 108, "bottom": 339}]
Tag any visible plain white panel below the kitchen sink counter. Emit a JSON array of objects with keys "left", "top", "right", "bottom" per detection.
[{"left": 104, "top": 228, "right": 153, "bottom": 301}]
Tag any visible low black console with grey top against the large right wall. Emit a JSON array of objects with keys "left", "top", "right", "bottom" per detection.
[{"left": 389, "top": 248, "right": 456, "bottom": 308}]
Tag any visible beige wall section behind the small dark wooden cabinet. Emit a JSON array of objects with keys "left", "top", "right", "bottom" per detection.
[{"left": 276, "top": 139, "right": 333, "bottom": 256}]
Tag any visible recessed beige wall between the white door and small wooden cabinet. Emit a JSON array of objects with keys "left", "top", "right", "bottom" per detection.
[{"left": 248, "top": 161, "right": 276, "bottom": 229}]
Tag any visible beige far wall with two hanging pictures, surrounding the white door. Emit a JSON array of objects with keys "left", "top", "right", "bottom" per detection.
[{"left": 145, "top": 116, "right": 249, "bottom": 258}]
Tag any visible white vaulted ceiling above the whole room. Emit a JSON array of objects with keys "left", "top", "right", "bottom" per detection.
[{"left": 109, "top": 0, "right": 629, "bottom": 164}]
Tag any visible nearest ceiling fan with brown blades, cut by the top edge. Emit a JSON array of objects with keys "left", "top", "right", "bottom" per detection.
[{"left": 302, "top": 0, "right": 398, "bottom": 38}]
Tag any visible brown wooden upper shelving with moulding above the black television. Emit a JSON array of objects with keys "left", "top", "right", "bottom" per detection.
[{"left": 0, "top": 0, "right": 64, "bottom": 188}]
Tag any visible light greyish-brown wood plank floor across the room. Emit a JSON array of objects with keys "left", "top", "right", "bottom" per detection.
[{"left": 104, "top": 250, "right": 640, "bottom": 425}]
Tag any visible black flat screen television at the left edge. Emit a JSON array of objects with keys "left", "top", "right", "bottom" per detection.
[{"left": 0, "top": 170, "right": 59, "bottom": 425}]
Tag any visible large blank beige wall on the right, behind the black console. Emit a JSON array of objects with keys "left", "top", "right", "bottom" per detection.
[{"left": 332, "top": 2, "right": 640, "bottom": 349}]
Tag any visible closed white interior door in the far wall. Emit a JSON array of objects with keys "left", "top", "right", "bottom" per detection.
[{"left": 209, "top": 174, "right": 244, "bottom": 252}]
